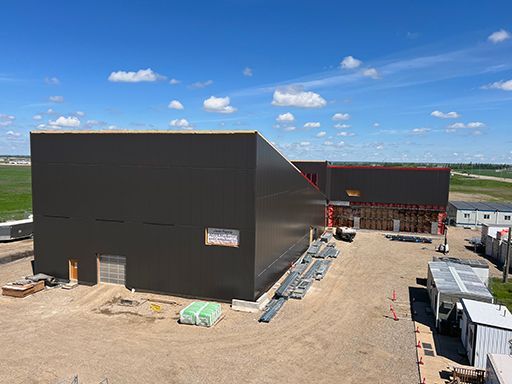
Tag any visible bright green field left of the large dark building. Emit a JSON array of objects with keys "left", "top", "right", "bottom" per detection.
[{"left": 0, "top": 165, "right": 32, "bottom": 221}]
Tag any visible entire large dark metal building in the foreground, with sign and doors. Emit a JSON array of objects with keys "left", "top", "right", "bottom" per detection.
[{"left": 31, "top": 131, "right": 325, "bottom": 300}]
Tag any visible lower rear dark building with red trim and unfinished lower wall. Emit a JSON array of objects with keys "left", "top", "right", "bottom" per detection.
[{"left": 293, "top": 161, "right": 450, "bottom": 234}]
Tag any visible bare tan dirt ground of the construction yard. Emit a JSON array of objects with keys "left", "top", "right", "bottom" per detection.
[{"left": 0, "top": 228, "right": 499, "bottom": 384}]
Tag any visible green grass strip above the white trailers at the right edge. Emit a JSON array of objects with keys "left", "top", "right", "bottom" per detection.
[{"left": 450, "top": 175, "right": 512, "bottom": 201}]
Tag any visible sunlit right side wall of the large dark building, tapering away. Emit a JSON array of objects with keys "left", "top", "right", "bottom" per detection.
[{"left": 255, "top": 136, "right": 325, "bottom": 296}]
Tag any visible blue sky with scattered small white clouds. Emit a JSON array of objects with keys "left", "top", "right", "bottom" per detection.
[{"left": 0, "top": 0, "right": 512, "bottom": 163}]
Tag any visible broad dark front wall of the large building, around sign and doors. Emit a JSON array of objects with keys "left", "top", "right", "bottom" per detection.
[{"left": 31, "top": 133, "right": 256, "bottom": 300}]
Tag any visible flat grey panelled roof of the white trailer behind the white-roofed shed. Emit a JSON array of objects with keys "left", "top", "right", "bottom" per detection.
[{"left": 428, "top": 261, "right": 493, "bottom": 300}]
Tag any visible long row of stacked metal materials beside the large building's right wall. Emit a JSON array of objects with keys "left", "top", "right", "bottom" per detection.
[{"left": 259, "top": 232, "right": 340, "bottom": 323}]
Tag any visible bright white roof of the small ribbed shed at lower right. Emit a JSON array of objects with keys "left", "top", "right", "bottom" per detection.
[{"left": 461, "top": 299, "right": 512, "bottom": 331}]
